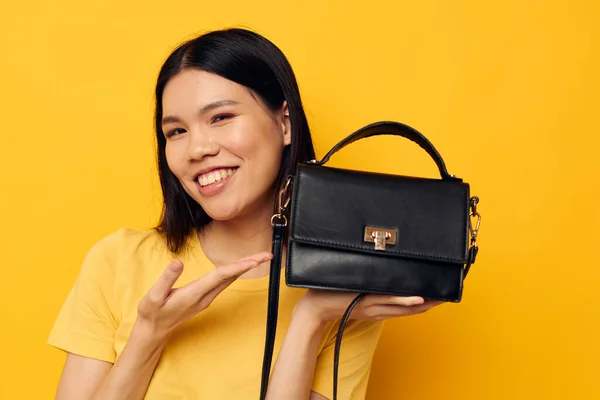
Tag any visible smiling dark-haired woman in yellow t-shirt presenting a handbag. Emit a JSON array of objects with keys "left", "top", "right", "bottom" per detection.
[{"left": 49, "top": 29, "right": 435, "bottom": 400}]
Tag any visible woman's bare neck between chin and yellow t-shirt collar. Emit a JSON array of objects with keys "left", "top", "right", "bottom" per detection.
[{"left": 199, "top": 197, "right": 273, "bottom": 278}]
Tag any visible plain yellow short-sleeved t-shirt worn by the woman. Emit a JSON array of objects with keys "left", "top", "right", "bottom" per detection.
[{"left": 48, "top": 229, "right": 382, "bottom": 400}]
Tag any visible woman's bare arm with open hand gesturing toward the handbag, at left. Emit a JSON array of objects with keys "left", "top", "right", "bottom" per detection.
[{"left": 56, "top": 253, "right": 271, "bottom": 400}]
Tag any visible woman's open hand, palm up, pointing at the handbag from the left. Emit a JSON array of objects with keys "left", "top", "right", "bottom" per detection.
[{"left": 136, "top": 252, "right": 273, "bottom": 340}]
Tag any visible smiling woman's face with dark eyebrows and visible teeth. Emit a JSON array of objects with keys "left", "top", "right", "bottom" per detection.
[{"left": 162, "top": 70, "right": 291, "bottom": 220}]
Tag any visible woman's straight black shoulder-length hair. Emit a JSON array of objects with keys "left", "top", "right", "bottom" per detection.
[{"left": 154, "top": 28, "right": 315, "bottom": 253}]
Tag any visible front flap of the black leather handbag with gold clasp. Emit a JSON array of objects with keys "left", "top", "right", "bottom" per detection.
[{"left": 290, "top": 164, "right": 469, "bottom": 263}]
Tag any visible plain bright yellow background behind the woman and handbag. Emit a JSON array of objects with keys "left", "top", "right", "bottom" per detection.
[{"left": 0, "top": 0, "right": 600, "bottom": 400}]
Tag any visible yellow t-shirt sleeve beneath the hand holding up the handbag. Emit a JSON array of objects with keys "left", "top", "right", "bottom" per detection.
[{"left": 312, "top": 320, "right": 383, "bottom": 400}]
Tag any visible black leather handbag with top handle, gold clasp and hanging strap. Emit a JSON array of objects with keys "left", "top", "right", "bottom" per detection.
[{"left": 261, "top": 122, "right": 481, "bottom": 400}]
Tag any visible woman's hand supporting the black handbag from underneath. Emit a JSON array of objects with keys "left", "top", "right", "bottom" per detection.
[{"left": 295, "top": 289, "right": 444, "bottom": 323}]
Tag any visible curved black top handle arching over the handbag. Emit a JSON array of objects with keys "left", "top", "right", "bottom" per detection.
[{"left": 312, "top": 121, "right": 462, "bottom": 182}]
